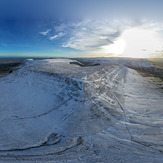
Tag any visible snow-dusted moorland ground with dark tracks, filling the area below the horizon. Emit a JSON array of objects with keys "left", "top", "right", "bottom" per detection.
[{"left": 0, "top": 59, "right": 163, "bottom": 163}]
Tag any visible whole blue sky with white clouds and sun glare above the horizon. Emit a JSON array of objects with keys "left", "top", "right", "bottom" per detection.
[{"left": 0, "top": 0, "right": 163, "bottom": 58}]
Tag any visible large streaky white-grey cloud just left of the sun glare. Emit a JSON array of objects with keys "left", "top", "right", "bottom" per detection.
[{"left": 62, "top": 21, "right": 124, "bottom": 51}]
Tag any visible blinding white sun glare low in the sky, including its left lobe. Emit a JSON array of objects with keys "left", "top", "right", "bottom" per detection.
[{"left": 103, "top": 27, "right": 163, "bottom": 58}]
